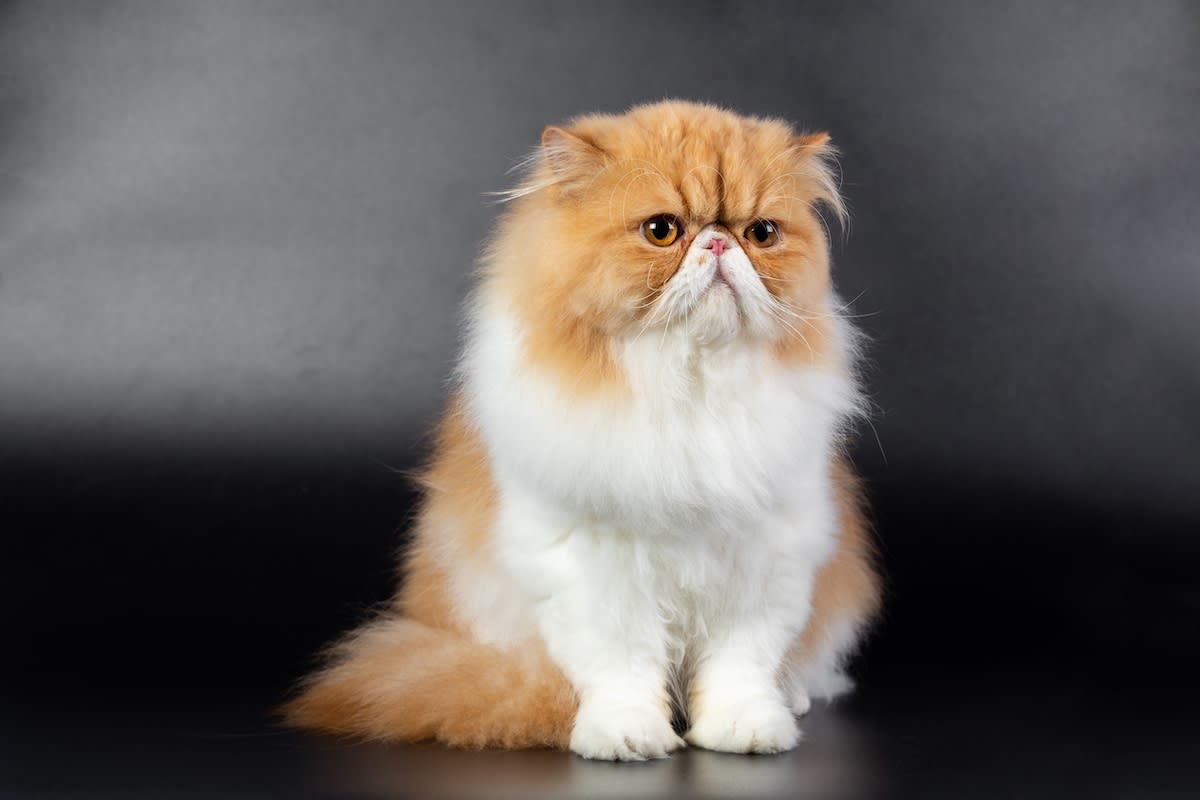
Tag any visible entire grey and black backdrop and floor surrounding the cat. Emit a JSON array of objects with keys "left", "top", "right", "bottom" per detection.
[{"left": 0, "top": 0, "right": 1200, "bottom": 800}]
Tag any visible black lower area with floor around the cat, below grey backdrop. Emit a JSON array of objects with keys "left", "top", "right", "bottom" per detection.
[{"left": 9, "top": 453, "right": 1200, "bottom": 798}]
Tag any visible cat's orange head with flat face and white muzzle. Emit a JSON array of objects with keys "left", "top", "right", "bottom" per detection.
[{"left": 486, "top": 102, "right": 845, "bottom": 388}]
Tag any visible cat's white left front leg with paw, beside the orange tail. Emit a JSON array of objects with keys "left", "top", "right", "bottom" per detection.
[{"left": 496, "top": 496, "right": 685, "bottom": 760}]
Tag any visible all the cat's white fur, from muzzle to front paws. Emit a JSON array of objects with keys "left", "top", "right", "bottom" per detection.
[{"left": 452, "top": 229, "right": 857, "bottom": 759}]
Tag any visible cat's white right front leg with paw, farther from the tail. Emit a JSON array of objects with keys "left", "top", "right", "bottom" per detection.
[{"left": 686, "top": 534, "right": 814, "bottom": 753}]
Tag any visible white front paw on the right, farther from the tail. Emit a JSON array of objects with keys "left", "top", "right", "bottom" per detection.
[{"left": 686, "top": 700, "right": 800, "bottom": 753}]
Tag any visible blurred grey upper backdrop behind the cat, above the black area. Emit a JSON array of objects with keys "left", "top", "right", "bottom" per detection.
[{"left": 0, "top": 0, "right": 1200, "bottom": 515}]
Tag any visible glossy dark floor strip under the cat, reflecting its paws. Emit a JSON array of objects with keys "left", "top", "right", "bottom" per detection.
[{"left": 0, "top": 672, "right": 1200, "bottom": 798}]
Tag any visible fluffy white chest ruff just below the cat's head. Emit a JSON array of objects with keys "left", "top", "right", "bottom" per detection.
[{"left": 476, "top": 326, "right": 836, "bottom": 529}]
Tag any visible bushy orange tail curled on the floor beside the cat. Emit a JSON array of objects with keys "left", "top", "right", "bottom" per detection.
[{"left": 283, "top": 614, "right": 578, "bottom": 750}]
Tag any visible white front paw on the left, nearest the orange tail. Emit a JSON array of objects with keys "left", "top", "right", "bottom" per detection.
[{"left": 571, "top": 703, "right": 688, "bottom": 762}]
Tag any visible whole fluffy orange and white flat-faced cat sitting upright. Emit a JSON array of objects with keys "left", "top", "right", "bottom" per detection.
[{"left": 286, "top": 101, "right": 880, "bottom": 760}]
